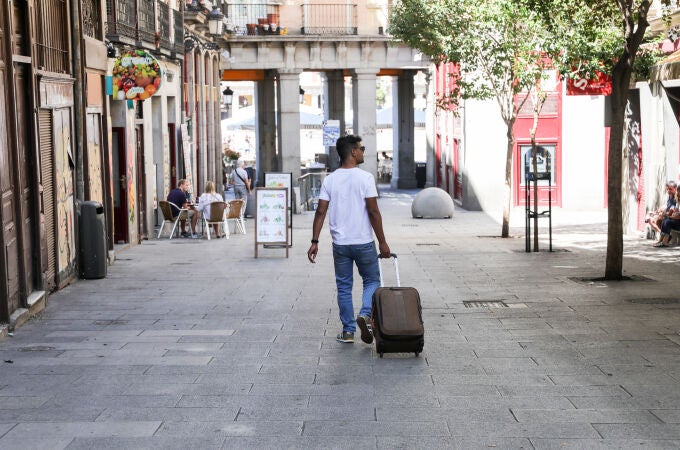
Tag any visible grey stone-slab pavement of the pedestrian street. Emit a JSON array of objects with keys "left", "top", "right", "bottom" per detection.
[{"left": 0, "top": 189, "right": 680, "bottom": 449}]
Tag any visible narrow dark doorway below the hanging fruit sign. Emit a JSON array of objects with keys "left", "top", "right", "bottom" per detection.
[{"left": 111, "top": 128, "right": 129, "bottom": 244}]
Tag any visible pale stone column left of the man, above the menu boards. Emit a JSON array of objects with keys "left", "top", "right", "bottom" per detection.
[{"left": 277, "top": 70, "right": 300, "bottom": 186}]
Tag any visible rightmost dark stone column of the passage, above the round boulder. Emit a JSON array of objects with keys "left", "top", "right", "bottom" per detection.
[{"left": 390, "top": 70, "right": 417, "bottom": 189}]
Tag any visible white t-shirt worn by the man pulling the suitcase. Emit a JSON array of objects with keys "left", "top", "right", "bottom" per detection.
[{"left": 319, "top": 167, "right": 378, "bottom": 245}]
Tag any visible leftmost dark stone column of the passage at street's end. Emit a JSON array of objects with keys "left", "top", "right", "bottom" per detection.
[{"left": 255, "top": 70, "right": 281, "bottom": 185}]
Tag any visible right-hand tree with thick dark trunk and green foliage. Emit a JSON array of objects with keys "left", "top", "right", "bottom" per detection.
[{"left": 529, "top": 0, "right": 669, "bottom": 280}]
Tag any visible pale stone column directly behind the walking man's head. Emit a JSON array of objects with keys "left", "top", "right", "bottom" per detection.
[{"left": 352, "top": 69, "right": 380, "bottom": 176}]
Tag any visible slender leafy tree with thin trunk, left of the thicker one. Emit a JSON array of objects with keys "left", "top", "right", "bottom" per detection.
[{"left": 389, "top": 0, "right": 554, "bottom": 237}]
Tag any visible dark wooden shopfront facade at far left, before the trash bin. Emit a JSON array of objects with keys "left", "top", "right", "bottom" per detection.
[{"left": 0, "top": 0, "right": 109, "bottom": 330}]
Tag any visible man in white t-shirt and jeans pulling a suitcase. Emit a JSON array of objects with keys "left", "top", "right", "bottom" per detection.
[{"left": 307, "top": 135, "right": 390, "bottom": 344}]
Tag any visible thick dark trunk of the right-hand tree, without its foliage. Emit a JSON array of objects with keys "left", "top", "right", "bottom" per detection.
[{"left": 604, "top": 64, "right": 631, "bottom": 280}]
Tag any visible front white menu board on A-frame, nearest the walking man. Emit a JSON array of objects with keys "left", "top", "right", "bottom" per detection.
[{"left": 255, "top": 188, "right": 288, "bottom": 258}]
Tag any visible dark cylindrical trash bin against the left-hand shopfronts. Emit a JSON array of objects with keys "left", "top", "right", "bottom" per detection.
[{"left": 78, "top": 201, "right": 107, "bottom": 279}]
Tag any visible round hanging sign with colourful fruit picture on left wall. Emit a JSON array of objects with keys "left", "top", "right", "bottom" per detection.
[{"left": 113, "top": 50, "right": 163, "bottom": 100}]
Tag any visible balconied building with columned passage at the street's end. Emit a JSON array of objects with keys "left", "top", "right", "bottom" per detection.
[{"left": 212, "top": 0, "right": 429, "bottom": 197}]
